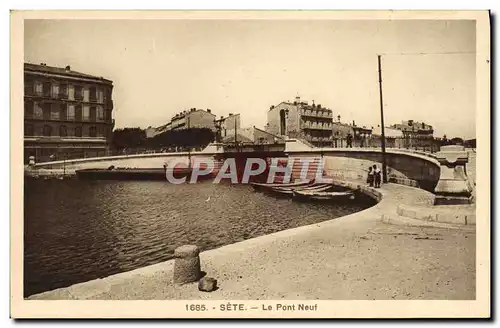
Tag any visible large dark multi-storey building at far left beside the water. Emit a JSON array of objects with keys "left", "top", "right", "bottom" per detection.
[{"left": 24, "top": 63, "right": 115, "bottom": 161}]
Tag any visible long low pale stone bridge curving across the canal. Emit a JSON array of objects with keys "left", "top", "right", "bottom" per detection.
[{"left": 28, "top": 139, "right": 440, "bottom": 191}]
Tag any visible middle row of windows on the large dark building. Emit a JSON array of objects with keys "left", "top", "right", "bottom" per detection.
[{"left": 24, "top": 101, "right": 107, "bottom": 121}]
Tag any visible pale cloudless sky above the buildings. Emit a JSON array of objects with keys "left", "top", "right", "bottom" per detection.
[{"left": 24, "top": 20, "right": 476, "bottom": 139}]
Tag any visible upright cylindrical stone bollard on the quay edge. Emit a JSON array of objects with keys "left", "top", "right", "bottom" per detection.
[{"left": 174, "top": 245, "right": 201, "bottom": 284}]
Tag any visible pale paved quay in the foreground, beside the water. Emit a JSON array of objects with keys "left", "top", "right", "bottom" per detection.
[{"left": 30, "top": 184, "right": 476, "bottom": 300}]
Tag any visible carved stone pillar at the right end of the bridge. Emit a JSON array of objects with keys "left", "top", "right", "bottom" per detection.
[{"left": 434, "top": 145, "right": 472, "bottom": 205}]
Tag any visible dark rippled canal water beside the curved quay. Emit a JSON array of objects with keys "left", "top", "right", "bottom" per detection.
[{"left": 24, "top": 179, "right": 374, "bottom": 297}]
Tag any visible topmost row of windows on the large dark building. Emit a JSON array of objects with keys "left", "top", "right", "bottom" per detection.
[{"left": 24, "top": 81, "right": 109, "bottom": 103}]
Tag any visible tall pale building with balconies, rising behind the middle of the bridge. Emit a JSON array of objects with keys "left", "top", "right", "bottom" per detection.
[{"left": 266, "top": 97, "right": 333, "bottom": 147}]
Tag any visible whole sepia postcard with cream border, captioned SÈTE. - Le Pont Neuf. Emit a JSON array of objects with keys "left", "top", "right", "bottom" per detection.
[{"left": 10, "top": 10, "right": 491, "bottom": 318}]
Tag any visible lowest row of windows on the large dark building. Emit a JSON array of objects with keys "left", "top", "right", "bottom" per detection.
[{"left": 24, "top": 124, "right": 108, "bottom": 138}]
